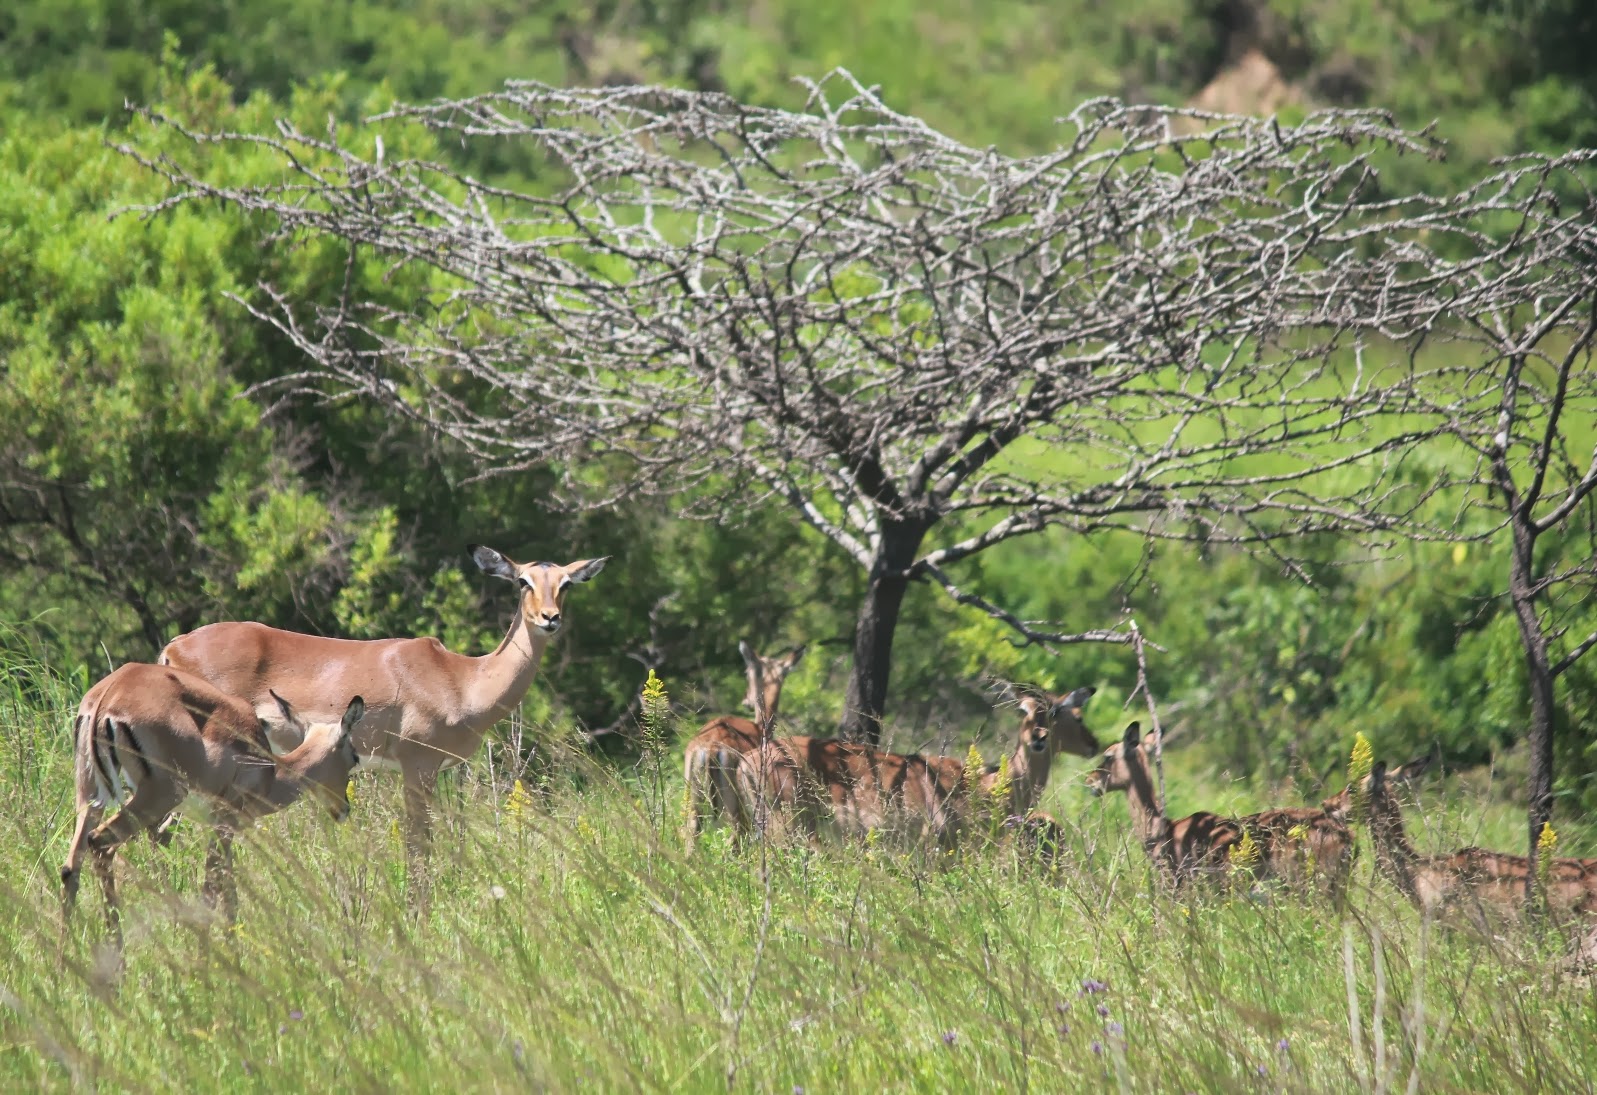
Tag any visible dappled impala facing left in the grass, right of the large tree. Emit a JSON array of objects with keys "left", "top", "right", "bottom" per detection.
[{"left": 1088, "top": 723, "right": 1353, "bottom": 900}]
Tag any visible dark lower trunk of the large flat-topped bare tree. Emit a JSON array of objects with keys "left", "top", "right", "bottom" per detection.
[{"left": 837, "top": 522, "right": 926, "bottom": 745}]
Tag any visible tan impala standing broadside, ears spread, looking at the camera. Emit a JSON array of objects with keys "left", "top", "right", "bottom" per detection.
[{"left": 161, "top": 544, "right": 608, "bottom": 865}]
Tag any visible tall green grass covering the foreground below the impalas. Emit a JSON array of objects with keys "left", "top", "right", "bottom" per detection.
[{"left": 0, "top": 657, "right": 1597, "bottom": 1093}]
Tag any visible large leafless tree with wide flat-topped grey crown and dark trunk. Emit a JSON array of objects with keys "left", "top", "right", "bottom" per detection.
[{"left": 128, "top": 73, "right": 1584, "bottom": 741}]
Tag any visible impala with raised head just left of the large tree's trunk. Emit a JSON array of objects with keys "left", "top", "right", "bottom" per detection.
[{"left": 682, "top": 642, "right": 805, "bottom": 849}]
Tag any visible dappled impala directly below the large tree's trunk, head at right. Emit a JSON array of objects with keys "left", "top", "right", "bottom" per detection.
[{"left": 738, "top": 688, "right": 1097, "bottom": 846}]
